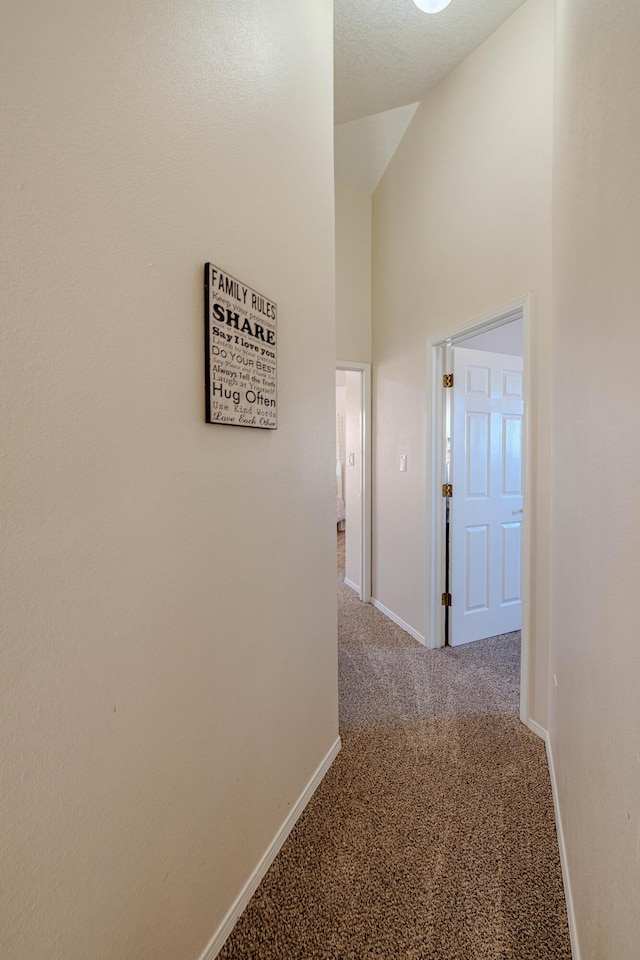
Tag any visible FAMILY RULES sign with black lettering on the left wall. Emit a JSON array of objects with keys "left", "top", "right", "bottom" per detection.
[{"left": 204, "top": 263, "right": 278, "bottom": 430}]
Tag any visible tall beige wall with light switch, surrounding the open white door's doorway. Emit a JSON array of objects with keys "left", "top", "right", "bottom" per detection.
[{"left": 373, "top": 0, "right": 553, "bottom": 725}]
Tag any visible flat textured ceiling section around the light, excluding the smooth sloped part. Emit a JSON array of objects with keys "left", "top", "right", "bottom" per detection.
[{"left": 334, "top": 0, "right": 524, "bottom": 123}]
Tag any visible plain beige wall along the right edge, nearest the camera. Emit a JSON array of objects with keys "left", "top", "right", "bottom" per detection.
[{"left": 550, "top": 0, "right": 640, "bottom": 960}]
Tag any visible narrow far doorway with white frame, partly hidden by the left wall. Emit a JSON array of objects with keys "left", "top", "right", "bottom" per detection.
[{"left": 336, "top": 361, "right": 371, "bottom": 603}]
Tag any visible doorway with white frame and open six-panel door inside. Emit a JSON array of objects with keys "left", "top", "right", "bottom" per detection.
[{"left": 427, "top": 296, "right": 530, "bottom": 722}]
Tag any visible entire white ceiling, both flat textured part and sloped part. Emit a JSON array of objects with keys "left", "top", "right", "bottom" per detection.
[{"left": 334, "top": 0, "right": 524, "bottom": 193}]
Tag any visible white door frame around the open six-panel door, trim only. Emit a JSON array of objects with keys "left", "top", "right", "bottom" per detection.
[{"left": 426, "top": 294, "right": 532, "bottom": 724}]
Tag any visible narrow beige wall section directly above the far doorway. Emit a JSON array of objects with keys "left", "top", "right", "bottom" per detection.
[{"left": 335, "top": 180, "right": 371, "bottom": 363}]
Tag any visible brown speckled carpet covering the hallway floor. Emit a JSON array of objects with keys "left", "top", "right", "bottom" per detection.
[{"left": 219, "top": 537, "right": 571, "bottom": 960}]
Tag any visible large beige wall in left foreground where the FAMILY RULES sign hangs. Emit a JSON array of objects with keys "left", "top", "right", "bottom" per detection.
[{"left": 0, "top": 0, "right": 337, "bottom": 960}]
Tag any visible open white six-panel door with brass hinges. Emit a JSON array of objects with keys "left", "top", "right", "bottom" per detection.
[{"left": 449, "top": 347, "right": 522, "bottom": 646}]
